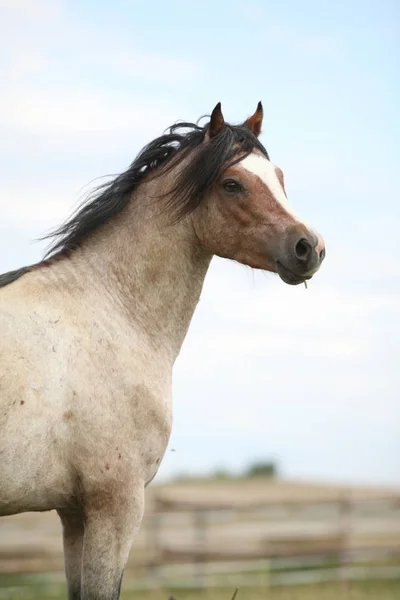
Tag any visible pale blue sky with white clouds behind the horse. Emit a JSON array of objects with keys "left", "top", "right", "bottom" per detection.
[{"left": 0, "top": 0, "right": 400, "bottom": 485}]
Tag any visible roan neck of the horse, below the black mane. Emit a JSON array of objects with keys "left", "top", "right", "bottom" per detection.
[{"left": 65, "top": 179, "right": 211, "bottom": 360}]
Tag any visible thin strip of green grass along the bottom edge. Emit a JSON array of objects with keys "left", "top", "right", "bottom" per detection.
[{"left": 0, "top": 576, "right": 400, "bottom": 600}]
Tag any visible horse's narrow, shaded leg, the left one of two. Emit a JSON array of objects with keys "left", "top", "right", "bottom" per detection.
[{"left": 58, "top": 511, "right": 84, "bottom": 600}]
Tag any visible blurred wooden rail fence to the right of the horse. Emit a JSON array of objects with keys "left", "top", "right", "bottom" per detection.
[{"left": 142, "top": 491, "right": 400, "bottom": 588}]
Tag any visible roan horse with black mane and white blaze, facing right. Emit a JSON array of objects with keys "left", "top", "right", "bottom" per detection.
[{"left": 0, "top": 102, "right": 325, "bottom": 600}]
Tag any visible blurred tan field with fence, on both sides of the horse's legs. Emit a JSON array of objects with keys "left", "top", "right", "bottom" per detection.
[{"left": 0, "top": 478, "right": 400, "bottom": 600}]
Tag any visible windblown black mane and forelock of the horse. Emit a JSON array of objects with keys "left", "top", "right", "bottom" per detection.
[{"left": 0, "top": 116, "right": 269, "bottom": 288}]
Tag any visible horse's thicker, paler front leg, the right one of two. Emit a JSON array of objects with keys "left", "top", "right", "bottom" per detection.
[{"left": 81, "top": 484, "right": 143, "bottom": 600}]
